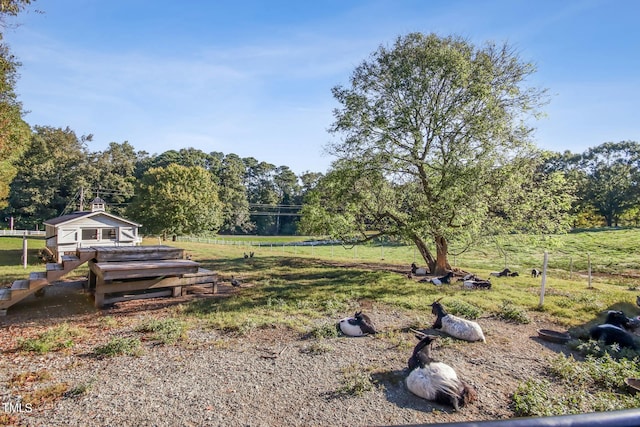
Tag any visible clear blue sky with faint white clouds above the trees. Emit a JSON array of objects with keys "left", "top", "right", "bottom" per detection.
[{"left": 5, "top": 0, "right": 640, "bottom": 174}]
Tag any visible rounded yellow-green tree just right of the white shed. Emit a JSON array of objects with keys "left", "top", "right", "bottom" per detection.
[{"left": 127, "top": 163, "right": 222, "bottom": 237}]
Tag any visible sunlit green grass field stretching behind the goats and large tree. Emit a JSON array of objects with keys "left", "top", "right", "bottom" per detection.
[{"left": 0, "top": 229, "right": 640, "bottom": 332}]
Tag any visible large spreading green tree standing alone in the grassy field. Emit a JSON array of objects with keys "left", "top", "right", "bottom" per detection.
[{"left": 303, "top": 33, "right": 557, "bottom": 272}]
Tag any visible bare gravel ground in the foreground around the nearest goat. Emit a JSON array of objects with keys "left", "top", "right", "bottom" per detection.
[{"left": 0, "top": 282, "right": 565, "bottom": 426}]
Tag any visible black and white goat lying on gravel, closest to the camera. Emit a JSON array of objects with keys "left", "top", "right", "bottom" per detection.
[{"left": 406, "top": 335, "right": 477, "bottom": 411}]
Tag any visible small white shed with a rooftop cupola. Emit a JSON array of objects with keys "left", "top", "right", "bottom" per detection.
[{"left": 44, "top": 197, "right": 142, "bottom": 262}]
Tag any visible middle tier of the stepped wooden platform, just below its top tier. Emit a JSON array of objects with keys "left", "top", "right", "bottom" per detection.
[{"left": 89, "top": 259, "right": 199, "bottom": 281}]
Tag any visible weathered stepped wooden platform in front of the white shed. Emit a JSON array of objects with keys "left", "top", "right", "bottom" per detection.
[{"left": 89, "top": 246, "right": 216, "bottom": 307}]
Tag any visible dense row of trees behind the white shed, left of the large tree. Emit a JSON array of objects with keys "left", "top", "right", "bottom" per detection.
[{"left": 2, "top": 126, "right": 321, "bottom": 235}]
